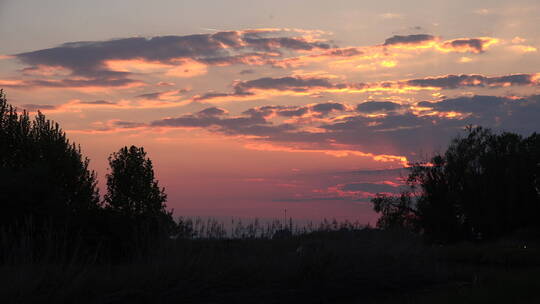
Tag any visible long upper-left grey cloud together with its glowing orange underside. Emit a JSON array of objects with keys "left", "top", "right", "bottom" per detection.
[{"left": 9, "top": 29, "right": 330, "bottom": 87}]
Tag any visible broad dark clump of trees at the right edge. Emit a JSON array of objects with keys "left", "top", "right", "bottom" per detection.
[{"left": 372, "top": 126, "right": 540, "bottom": 242}]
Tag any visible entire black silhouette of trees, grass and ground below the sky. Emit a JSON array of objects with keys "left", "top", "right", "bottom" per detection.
[{"left": 0, "top": 91, "right": 540, "bottom": 303}]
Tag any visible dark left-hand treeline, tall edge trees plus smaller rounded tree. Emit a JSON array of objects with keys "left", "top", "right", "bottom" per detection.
[{"left": 0, "top": 90, "right": 176, "bottom": 262}]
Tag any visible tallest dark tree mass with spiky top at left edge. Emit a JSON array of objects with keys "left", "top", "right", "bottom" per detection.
[{"left": 0, "top": 90, "right": 99, "bottom": 225}]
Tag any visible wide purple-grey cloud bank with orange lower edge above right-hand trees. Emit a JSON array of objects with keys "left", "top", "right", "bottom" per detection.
[{"left": 78, "top": 95, "right": 540, "bottom": 167}]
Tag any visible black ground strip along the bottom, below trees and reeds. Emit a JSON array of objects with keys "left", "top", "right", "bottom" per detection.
[{"left": 0, "top": 229, "right": 540, "bottom": 303}]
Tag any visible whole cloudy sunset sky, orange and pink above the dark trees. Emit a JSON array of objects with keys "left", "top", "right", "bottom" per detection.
[{"left": 0, "top": 0, "right": 540, "bottom": 223}]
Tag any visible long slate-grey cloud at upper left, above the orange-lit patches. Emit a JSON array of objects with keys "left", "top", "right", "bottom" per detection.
[{"left": 14, "top": 31, "right": 330, "bottom": 87}]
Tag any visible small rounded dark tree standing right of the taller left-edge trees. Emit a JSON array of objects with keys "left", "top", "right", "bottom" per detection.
[{"left": 105, "top": 146, "right": 174, "bottom": 234}]
